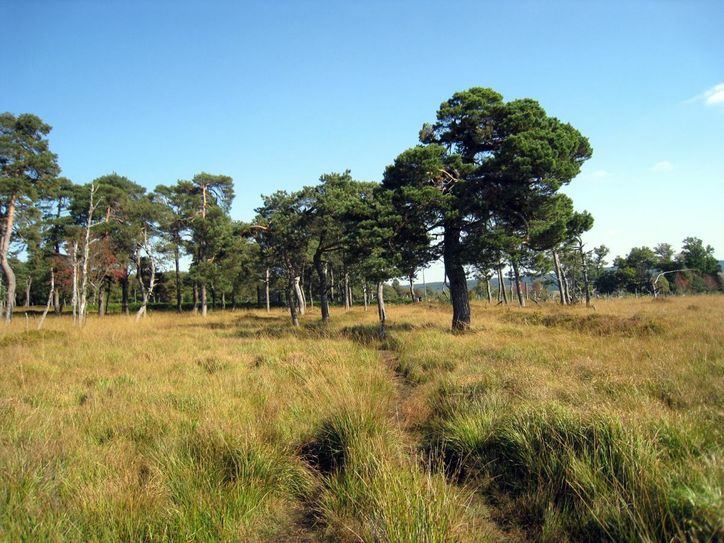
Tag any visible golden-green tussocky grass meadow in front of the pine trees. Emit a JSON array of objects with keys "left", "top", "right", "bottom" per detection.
[{"left": 0, "top": 296, "right": 724, "bottom": 542}]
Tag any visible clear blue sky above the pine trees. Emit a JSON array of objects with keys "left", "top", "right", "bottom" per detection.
[{"left": 0, "top": 0, "right": 724, "bottom": 280}]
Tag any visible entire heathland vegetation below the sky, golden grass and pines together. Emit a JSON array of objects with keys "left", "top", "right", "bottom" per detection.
[{"left": 0, "top": 88, "right": 724, "bottom": 542}]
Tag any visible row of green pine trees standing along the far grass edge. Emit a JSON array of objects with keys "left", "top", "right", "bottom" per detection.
[{"left": 0, "top": 87, "right": 718, "bottom": 330}]
